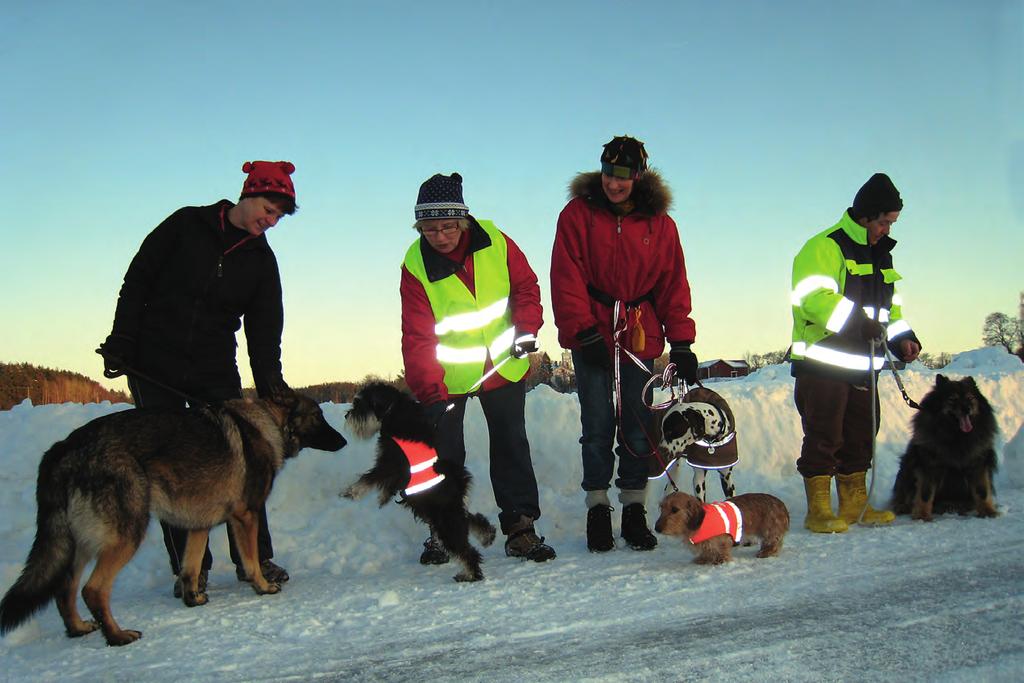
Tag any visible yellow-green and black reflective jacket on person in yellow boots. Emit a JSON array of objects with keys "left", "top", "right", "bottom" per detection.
[{"left": 791, "top": 212, "right": 916, "bottom": 384}]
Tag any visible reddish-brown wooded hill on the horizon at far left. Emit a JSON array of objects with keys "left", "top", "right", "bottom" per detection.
[{"left": 0, "top": 362, "right": 131, "bottom": 411}]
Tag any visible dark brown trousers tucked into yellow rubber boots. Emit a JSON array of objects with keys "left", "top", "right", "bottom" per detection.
[{"left": 794, "top": 375, "right": 881, "bottom": 477}]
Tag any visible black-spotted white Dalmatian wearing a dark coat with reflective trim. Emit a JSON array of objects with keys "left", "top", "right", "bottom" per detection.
[{"left": 658, "top": 387, "right": 739, "bottom": 501}]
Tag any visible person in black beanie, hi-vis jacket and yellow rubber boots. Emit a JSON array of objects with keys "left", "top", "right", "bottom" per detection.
[{"left": 791, "top": 173, "right": 921, "bottom": 533}]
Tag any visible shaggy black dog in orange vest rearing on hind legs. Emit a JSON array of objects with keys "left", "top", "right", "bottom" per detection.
[{"left": 342, "top": 382, "right": 496, "bottom": 581}]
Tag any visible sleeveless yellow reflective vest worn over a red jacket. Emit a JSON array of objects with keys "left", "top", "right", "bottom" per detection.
[{"left": 403, "top": 220, "right": 529, "bottom": 394}]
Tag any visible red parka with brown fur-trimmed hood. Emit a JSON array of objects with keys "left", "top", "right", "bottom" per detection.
[{"left": 551, "top": 171, "right": 696, "bottom": 359}]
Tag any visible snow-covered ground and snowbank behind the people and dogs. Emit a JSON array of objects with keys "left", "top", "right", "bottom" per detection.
[{"left": 0, "top": 348, "right": 1024, "bottom": 682}]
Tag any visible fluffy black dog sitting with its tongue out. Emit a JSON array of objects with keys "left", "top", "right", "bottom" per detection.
[{"left": 892, "top": 375, "right": 998, "bottom": 521}]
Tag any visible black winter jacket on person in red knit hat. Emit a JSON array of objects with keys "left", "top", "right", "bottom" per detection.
[{"left": 112, "top": 200, "right": 284, "bottom": 395}]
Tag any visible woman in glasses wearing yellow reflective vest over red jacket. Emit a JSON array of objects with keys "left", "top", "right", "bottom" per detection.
[{"left": 400, "top": 173, "right": 555, "bottom": 564}]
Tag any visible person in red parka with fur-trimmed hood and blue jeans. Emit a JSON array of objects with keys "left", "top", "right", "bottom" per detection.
[{"left": 551, "top": 136, "right": 697, "bottom": 552}]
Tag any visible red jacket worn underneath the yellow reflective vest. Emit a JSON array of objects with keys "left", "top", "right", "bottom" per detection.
[{"left": 400, "top": 217, "right": 544, "bottom": 403}]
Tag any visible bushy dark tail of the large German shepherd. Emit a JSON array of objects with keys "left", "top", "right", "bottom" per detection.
[{"left": 0, "top": 441, "right": 76, "bottom": 635}]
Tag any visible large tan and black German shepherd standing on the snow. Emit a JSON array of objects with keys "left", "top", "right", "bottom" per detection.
[{"left": 0, "top": 390, "right": 345, "bottom": 645}]
